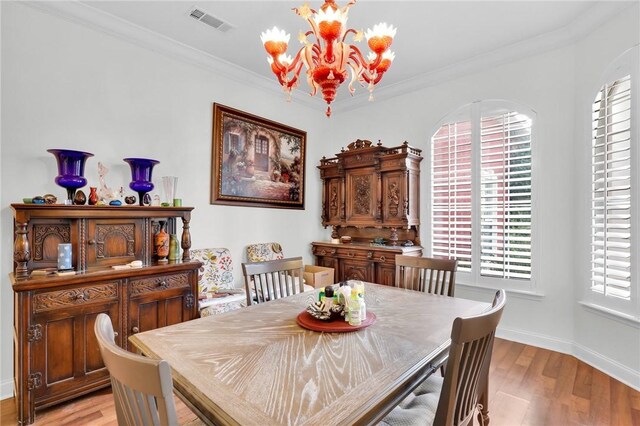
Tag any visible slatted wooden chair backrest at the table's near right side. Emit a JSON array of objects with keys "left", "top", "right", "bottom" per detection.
[{"left": 434, "top": 290, "right": 506, "bottom": 426}]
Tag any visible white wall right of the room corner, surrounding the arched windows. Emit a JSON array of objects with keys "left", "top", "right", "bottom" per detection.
[{"left": 332, "top": 5, "right": 640, "bottom": 389}]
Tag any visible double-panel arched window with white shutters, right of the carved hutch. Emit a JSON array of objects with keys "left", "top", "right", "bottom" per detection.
[{"left": 430, "top": 101, "right": 535, "bottom": 290}]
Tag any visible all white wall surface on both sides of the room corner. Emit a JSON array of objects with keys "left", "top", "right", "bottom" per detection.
[{"left": 0, "top": 3, "right": 640, "bottom": 398}]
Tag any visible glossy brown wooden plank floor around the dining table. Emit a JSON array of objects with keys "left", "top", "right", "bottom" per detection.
[{"left": 0, "top": 339, "right": 640, "bottom": 426}]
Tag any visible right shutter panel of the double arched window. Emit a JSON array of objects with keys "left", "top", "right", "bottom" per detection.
[{"left": 480, "top": 112, "right": 531, "bottom": 279}]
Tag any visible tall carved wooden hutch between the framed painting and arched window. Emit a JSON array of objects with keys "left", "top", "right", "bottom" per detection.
[{"left": 311, "top": 139, "right": 422, "bottom": 285}]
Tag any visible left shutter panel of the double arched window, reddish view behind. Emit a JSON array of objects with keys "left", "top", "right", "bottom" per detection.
[{"left": 431, "top": 121, "right": 472, "bottom": 271}]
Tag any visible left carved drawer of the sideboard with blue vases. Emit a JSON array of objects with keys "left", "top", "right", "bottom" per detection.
[{"left": 33, "top": 281, "right": 119, "bottom": 313}]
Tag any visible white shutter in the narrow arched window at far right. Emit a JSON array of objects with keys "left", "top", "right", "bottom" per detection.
[{"left": 591, "top": 76, "right": 632, "bottom": 300}]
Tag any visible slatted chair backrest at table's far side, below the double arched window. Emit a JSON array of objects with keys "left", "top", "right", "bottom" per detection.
[{"left": 395, "top": 255, "right": 458, "bottom": 297}]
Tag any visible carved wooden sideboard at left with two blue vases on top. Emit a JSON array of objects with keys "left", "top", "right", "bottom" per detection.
[{"left": 10, "top": 204, "right": 201, "bottom": 424}]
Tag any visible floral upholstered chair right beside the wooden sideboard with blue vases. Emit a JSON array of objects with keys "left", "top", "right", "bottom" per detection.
[{"left": 191, "top": 248, "right": 247, "bottom": 317}]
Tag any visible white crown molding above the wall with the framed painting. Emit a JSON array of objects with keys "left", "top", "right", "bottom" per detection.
[{"left": 21, "top": 0, "right": 324, "bottom": 109}]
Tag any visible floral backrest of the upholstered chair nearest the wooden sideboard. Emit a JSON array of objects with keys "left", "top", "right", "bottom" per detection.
[{"left": 189, "top": 248, "right": 233, "bottom": 293}]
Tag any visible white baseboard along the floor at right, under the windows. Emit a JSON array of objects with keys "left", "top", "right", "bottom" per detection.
[{"left": 496, "top": 327, "right": 640, "bottom": 392}]
